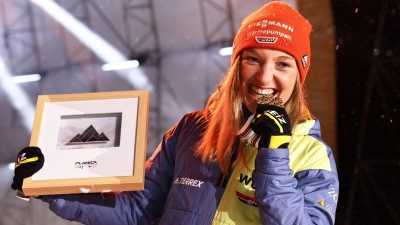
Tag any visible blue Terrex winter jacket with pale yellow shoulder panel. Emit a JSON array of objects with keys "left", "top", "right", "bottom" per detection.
[{"left": 42, "top": 111, "right": 339, "bottom": 225}]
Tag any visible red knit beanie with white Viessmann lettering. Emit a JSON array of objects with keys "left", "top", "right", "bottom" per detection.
[{"left": 231, "top": 1, "right": 312, "bottom": 84}]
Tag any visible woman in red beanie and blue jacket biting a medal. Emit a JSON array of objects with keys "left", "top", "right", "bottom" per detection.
[{"left": 13, "top": 1, "right": 338, "bottom": 225}]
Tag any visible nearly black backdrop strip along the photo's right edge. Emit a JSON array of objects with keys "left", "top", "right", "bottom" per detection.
[{"left": 332, "top": 0, "right": 400, "bottom": 225}]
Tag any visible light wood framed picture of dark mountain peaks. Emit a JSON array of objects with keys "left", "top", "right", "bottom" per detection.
[{"left": 22, "top": 90, "right": 149, "bottom": 196}]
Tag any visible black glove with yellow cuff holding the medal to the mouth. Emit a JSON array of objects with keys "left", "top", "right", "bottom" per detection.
[{"left": 250, "top": 105, "right": 292, "bottom": 148}]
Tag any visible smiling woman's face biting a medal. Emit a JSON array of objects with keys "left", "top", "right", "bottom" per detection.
[{"left": 240, "top": 48, "right": 298, "bottom": 113}]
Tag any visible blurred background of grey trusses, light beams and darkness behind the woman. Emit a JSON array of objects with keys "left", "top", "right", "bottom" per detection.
[{"left": 0, "top": 0, "right": 400, "bottom": 225}]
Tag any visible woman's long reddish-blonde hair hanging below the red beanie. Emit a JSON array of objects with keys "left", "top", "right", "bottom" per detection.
[{"left": 196, "top": 57, "right": 305, "bottom": 175}]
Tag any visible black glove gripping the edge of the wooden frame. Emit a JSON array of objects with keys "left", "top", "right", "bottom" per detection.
[{"left": 11, "top": 147, "right": 44, "bottom": 191}]
